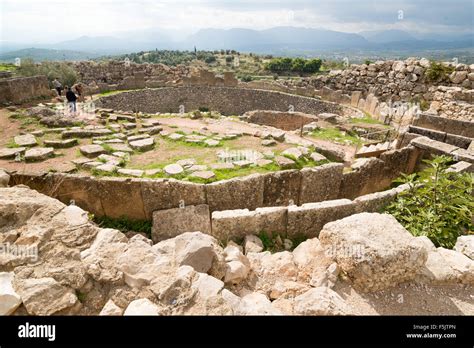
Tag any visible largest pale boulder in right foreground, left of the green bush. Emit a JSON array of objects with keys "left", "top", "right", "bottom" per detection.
[{"left": 319, "top": 213, "right": 427, "bottom": 291}]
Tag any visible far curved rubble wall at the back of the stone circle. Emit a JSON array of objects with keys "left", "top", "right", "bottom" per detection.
[{"left": 97, "top": 86, "right": 342, "bottom": 115}]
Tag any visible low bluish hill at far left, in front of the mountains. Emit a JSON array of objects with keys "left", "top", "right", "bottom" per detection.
[{"left": 0, "top": 48, "right": 98, "bottom": 62}]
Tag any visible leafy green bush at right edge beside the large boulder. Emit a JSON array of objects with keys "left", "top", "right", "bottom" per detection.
[{"left": 386, "top": 156, "right": 474, "bottom": 248}]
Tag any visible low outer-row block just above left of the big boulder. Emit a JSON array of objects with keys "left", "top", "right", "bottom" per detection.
[{"left": 287, "top": 199, "right": 356, "bottom": 238}]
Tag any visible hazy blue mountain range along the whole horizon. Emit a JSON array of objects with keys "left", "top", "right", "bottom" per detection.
[{"left": 0, "top": 27, "right": 474, "bottom": 60}]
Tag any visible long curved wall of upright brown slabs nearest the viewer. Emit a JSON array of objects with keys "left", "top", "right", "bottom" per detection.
[{"left": 2, "top": 147, "right": 418, "bottom": 220}]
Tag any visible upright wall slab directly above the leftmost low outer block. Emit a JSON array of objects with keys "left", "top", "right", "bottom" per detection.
[{"left": 140, "top": 179, "right": 206, "bottom": 220}]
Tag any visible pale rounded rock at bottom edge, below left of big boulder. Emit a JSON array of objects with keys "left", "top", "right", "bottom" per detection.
[{"left": 294, "top": 287, "right": 351, "bottom": 315}]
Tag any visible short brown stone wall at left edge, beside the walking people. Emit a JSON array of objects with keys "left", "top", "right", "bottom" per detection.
[{"left": 0, "top": 76, "right": 52, "bottom": 104}]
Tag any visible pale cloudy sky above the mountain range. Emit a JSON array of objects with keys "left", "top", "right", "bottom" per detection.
[{"left": 0, "top": 0, "right": 474, "bottom": 42}]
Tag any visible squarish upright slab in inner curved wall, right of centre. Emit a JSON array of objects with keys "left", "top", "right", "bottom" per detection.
[{"left": 297, "top": 163, "right": 344, "bottom": 204}]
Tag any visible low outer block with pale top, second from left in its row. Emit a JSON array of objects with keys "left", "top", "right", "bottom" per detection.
[{"left": 212, "top": 207, "right": 287, "bottom": 240}]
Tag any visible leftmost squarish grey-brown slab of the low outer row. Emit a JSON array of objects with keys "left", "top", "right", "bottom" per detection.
[{"left": 151, "top": 204, "right": 211, "bottom": 243}]
